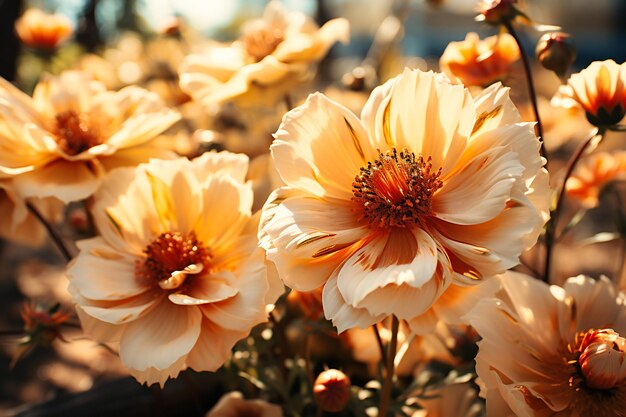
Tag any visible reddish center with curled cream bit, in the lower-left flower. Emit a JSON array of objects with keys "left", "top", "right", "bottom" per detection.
[{"left": 135, "top": 232, "right": 211, "bottom": 290}]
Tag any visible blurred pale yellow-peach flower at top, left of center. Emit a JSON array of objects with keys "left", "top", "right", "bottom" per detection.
[{"left": 179, "top": 1, "right": 349, "bottom": 105}]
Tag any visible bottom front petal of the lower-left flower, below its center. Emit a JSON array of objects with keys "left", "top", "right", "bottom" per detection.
[{"left": 120, "top": 299, "right": 202, "bottom": 371}]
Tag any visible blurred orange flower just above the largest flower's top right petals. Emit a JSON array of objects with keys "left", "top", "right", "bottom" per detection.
[{"left": 439, "top": 32, "right": 520, "bottom": 86}]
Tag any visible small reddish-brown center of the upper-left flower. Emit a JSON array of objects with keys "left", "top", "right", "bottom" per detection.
[{"left": 56, "top": 110, "right": 102, "bottom": 155}]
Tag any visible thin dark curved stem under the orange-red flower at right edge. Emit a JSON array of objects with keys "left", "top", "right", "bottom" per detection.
[{"left": 543, "top": 129, "right": 604, "bottom": 282}]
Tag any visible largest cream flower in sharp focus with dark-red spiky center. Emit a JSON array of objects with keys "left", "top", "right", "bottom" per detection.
[{"left": 260, "top": 70, "right": 549, "bottom": 331}]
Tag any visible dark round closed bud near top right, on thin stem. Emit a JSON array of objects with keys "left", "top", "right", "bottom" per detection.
[{"left": 535, "top": 32, "right": 576, "bottom": 80}]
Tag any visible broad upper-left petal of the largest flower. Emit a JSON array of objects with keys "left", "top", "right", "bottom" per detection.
[{"left": 270, "top": 93, "right": 377, "bottom": 200}]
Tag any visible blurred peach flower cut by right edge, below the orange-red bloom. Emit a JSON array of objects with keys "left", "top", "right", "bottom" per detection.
[{"left": 566, "top": 151, "right": 626, "bottom": 207}]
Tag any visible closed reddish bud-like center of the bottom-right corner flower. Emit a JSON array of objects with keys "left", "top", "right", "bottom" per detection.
[{"left": 578, "top": 329, "right": 626, "bottom": 390}]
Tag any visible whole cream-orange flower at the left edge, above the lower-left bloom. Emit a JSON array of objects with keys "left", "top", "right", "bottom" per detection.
[{"left": 0, "top": 71, "right": 180, "bottom": 203}]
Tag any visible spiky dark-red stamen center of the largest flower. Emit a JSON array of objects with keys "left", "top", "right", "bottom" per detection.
[{"left": 352, "top": 148, "right": 443, "bottom": 228}]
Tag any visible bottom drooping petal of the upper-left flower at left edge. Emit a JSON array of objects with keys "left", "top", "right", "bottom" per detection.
[{"left": 15, "top": 159, "right": 104, "bottom": 203}]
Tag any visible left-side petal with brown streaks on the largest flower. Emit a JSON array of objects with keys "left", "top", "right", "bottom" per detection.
[{"left": 263, "top": 191, "right": 368, "bottom": 291}]
